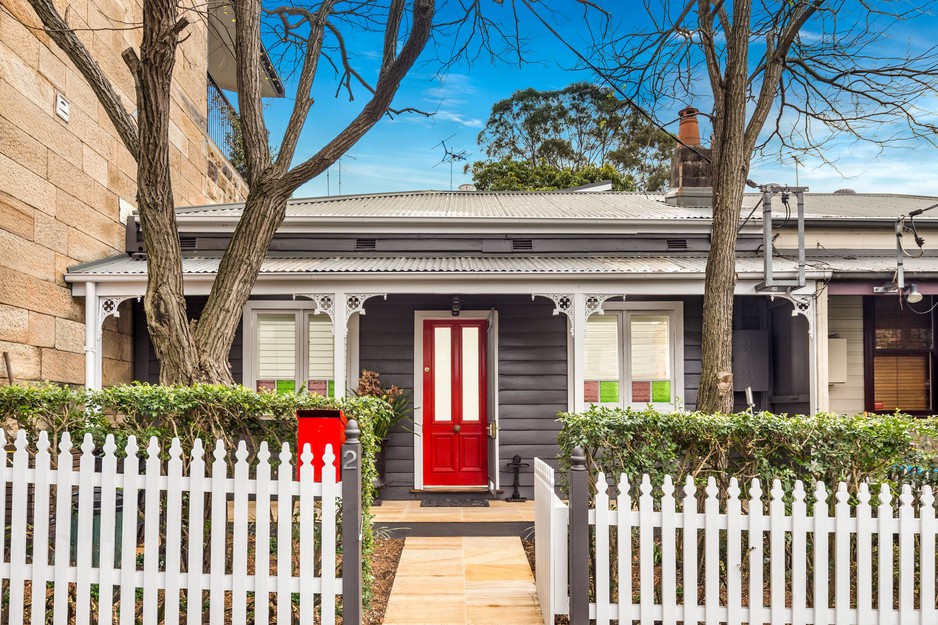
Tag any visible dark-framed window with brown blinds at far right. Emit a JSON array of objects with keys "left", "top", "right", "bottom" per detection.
[{"left": 868, "top": 297, "right": 935, "bottom": 412}]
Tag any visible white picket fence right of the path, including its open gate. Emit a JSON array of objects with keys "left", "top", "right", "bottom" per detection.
[{"left": 535, "top": 453, "right": 938, "bottom": 625}]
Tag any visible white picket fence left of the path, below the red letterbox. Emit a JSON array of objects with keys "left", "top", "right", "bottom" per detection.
[{"left": 0, "top": 431, "right": 342, "bottom": 625}]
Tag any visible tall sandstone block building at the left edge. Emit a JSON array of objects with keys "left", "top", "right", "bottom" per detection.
[{"left": 0, "top": 0, "right": 283, "bottom": 385}]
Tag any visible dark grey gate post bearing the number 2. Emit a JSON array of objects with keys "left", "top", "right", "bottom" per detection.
[{"left": 339, "top": 419, "right": 362, "bottom": 625}]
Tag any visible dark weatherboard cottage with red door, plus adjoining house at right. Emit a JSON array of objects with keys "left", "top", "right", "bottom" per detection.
[{"left": 66, "top": 111, "right": 938, "bottom": 498}]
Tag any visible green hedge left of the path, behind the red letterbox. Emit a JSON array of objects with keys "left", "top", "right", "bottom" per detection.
[{"left": 0, "top": 384, "right": 392, "bottom": 601}]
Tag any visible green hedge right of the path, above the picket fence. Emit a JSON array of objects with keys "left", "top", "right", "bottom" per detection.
[{"left": 559, "top": 407, "right": 938, "bottom": 489}]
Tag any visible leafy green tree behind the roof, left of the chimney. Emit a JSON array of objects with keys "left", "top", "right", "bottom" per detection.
[{"left": 466, "top": 82, "right": 674, "bottom": 191}]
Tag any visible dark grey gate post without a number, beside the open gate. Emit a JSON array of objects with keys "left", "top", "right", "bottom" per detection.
[{"left": 567, "top": 447, "right": 590, "bottom": 625}]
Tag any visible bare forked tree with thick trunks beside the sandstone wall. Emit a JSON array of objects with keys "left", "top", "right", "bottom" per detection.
[{"left": 28, "top": 0, "right": 511, "bottom": 384}]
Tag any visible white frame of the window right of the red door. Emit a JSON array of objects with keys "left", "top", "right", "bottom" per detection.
[{"left": 584, "top": 301, "right": 684, "bottom": 410}]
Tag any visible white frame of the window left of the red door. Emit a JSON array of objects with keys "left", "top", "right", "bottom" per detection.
[{"left": 241, "top": 301, "right": 338, "bottom": 390}]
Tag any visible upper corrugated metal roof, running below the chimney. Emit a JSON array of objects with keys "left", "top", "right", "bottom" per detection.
[{"left": 170, "top": 191, "right": 938, "bottom": 221}]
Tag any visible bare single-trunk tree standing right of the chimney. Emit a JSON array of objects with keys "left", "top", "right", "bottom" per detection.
[{"left": 584, "top": 0, "right": 938, "bottom": 412}]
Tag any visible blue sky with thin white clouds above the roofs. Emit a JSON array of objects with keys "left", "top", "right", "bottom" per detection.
[{"left": 258, "top": 2, "right": 938, "bottom": 197}]
